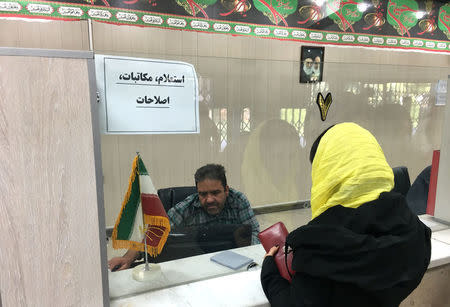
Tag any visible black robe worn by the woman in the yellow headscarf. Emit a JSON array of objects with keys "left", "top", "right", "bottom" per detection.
[{"left": 261, "top": 192, "right": 431, "bottom": 307}]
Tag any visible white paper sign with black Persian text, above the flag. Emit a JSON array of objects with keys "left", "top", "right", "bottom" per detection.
[{"left": 95, "top": 55, "right": 200, "bottom": 134}]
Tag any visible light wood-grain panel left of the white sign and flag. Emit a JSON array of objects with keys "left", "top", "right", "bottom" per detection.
[{"left": 0, "top": 56, "right": 103, "bottom": 307}]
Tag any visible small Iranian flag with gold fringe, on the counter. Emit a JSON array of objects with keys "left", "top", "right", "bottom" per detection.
[{"left": 112, "top": 155, "right": 170, "bottom": 257}]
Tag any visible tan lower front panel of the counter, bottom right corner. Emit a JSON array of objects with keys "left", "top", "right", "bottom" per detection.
[{"left": 400, "top": 264, "right": 450, "bottom": 307}]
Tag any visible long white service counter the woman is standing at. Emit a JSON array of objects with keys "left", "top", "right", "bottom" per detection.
[{"left": 109, "top": 216, "right": 450, "bottom": 307}]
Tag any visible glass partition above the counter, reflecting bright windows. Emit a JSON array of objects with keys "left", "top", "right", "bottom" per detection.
[{"left": 101, "top": 55, "right": 448, "bottom": 300}]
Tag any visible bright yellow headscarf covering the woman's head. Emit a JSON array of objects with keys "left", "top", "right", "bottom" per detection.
[{"left": 311, "top": 123, "right": 394, "bottom": 219}]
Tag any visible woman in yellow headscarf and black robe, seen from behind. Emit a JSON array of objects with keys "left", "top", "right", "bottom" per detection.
[{"left": 261, "top": 123, "right": 431, "bottom": 307}]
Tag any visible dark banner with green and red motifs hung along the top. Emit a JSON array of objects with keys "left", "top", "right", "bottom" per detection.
[{"left": 0, "top": 0, "right": 450, "bottom": 53}]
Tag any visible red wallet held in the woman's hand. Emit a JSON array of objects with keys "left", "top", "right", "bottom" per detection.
[{"left": 258, "top": 222, "right": 295, "bottom": 282}]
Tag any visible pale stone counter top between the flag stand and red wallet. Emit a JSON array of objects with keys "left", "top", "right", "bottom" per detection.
[{"left": 108, "top": 244, "right": 265, "bottom": 300}]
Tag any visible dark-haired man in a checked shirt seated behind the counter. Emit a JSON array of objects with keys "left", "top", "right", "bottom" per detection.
[{"left": 108, "top": 164, "right": 259, "bottom": 270}]
